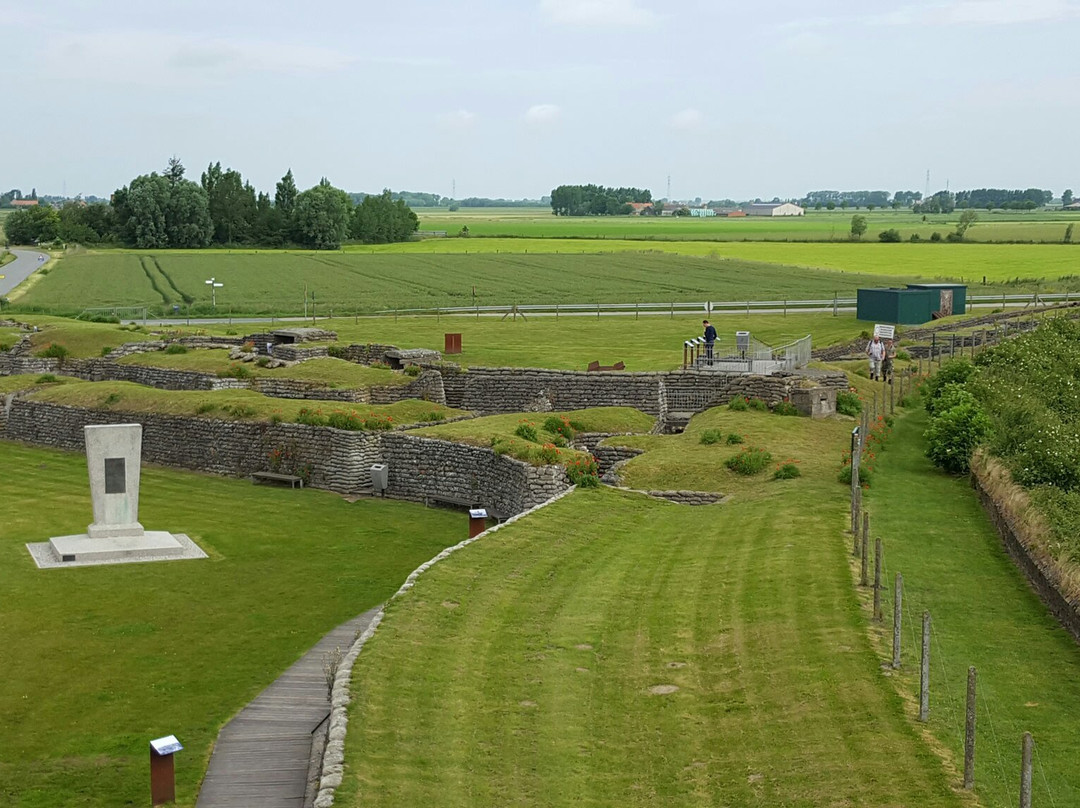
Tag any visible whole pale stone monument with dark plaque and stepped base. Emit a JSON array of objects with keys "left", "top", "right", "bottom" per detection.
[{"left": 27, "top": 423, "right": 206, "bottom": 567}]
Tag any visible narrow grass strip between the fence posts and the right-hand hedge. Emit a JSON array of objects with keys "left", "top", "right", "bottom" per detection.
[{"left": 865, "top": 410, "right": 1080, "bottom": 808}]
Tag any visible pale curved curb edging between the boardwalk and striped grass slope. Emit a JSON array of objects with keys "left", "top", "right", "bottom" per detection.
[{"left": 314, "top": 486, "right": 577, "bottom": 808}]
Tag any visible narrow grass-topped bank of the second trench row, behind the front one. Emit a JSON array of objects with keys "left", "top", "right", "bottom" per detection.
[{"left": 117, "top": 349, "right": 413, "bottom": 388}]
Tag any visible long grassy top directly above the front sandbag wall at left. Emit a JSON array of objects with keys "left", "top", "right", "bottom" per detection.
[{"left": 27, "top": 381, "right": 464, "bottom": 423}]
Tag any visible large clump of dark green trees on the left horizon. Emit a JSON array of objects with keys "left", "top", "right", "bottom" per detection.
[{"left": 4, "top": 158, "right": 419, "bottom": 250}]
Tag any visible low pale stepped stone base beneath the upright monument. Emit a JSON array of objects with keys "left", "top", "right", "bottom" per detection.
[{"left": 26, "top": 530, "right": 206, "bottom": 569}]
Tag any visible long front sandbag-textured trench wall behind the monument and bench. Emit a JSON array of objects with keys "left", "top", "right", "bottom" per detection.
[{"left": 2, "top": 396, "right": 569, "bottom": 515}]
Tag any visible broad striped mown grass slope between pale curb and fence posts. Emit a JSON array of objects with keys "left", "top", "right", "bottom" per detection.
[{"left": 337, "top": 416, "right": 963, "bottom": 807}]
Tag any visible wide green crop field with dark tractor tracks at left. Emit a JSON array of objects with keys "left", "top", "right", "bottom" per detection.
[{"left": 10, "top": 249, "right": 920, "bottom": 315}]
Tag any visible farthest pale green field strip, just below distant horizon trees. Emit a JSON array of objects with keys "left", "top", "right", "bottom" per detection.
[{"left": 417, "top": 207, "right": 1080, "bottom": 242}]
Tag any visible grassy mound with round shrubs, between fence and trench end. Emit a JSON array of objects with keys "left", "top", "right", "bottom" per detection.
[{"left": 606, "top": 406, "right": 853, "bottom": 500}]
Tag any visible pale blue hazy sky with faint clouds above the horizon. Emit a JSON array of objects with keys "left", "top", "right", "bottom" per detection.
[{"left": 0, "top": 0, "right": 1080, "bottom": 200}]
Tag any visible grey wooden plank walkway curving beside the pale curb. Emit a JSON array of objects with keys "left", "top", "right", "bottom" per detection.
[{"left": 195, "top": 608, "right": 378, "bottom": 808}]
